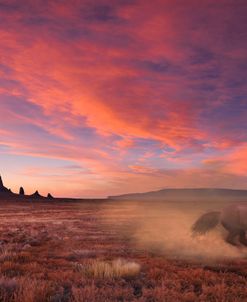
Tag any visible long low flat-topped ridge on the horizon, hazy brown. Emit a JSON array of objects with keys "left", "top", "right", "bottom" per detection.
[{"left": 108, "top": 188, "right": 247, "bottom": 202}]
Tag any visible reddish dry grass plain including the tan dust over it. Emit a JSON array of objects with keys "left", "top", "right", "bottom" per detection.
[{"left": 0, "top": 201, "right": 247, "bottom": 302}]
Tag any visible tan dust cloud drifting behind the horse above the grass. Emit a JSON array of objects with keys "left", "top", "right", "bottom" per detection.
[{"left": 99, "top": 201, "right": 247, "bottom": 261}]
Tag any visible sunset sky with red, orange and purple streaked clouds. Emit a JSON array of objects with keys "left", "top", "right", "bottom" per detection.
[{"left": 0, "top": 0, "right": 247, "bottom": 197}]
